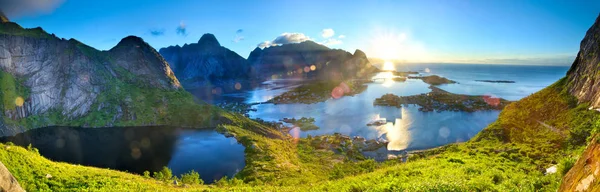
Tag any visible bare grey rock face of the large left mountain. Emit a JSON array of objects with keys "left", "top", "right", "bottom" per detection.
[{"left": 0, "top": 22, "right": 185, "bottom": 136}]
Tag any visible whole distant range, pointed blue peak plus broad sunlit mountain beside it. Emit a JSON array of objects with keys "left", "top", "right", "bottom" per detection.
[{"left": 159, "top": 34, "right": 374, "bottom": 88}]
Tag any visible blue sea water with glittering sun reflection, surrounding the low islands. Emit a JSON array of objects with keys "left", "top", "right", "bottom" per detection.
[{"left": 203, "top": 64, "right": 569, "bottom": 150}]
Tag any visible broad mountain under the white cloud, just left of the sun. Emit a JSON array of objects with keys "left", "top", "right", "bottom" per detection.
[{"left": 248, "top": 41, "right": 374, "bottom": 80}]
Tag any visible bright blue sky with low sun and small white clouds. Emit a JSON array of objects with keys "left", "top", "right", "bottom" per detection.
[{"left": 0, "top": 0, "right": 600, "bottom": 65}]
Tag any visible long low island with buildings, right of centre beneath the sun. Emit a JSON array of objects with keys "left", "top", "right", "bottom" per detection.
[{"left": 373, "top": 86, "right": 510, "bottom": 112}]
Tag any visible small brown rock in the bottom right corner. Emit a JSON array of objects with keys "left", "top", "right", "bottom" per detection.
[{"left": 558, "top": 138, "right": 600, "bottom": 191}]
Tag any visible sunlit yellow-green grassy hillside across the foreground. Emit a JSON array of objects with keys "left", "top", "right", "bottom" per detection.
[{"left": 0, "top": 77, "right": 598, "bottom": 191}]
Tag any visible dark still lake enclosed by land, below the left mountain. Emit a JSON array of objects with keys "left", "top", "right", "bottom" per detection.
[{"left": 0, "top": 127, "right": 245, "bottom": 183}]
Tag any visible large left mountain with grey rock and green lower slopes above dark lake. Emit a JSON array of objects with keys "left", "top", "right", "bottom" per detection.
[{"left": 0, "top": 17, "right": 220, "bottom": 136}]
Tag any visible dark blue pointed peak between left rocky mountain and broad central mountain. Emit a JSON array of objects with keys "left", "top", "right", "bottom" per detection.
[{"left": 159, "top": 34, "right": 250, "bottom": 88}]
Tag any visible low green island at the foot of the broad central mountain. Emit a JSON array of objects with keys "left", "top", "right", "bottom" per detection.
[{"left": 268, "top": 79, "right": 371, "bottom": 104}]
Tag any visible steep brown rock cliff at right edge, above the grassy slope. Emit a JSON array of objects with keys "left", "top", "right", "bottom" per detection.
[{"left": 567, "top": 14, "right": 600, "bottom": 108}]
